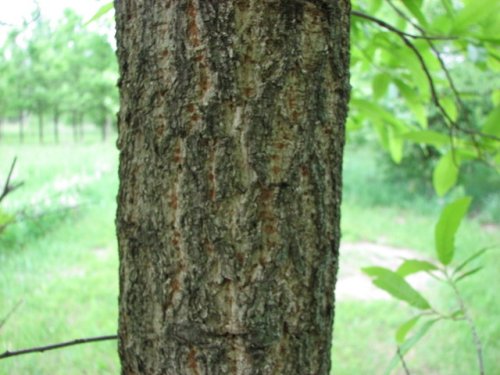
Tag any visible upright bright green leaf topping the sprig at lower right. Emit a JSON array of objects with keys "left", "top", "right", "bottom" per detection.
[{"left": 434, "top": 197, "right": 471, "bottom": 265}]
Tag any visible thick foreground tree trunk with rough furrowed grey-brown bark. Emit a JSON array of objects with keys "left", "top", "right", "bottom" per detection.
[{"left": 115, "top": 0, "right": 350, "bottom": 375}]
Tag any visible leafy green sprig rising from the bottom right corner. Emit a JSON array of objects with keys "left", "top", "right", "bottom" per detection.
[{"left": 363, "top": 197, "right": 488, "bottom": 375}]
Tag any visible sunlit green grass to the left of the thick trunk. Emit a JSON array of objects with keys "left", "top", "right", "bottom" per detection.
[{"left": 0, "top": 140, "right": 119, "bottom": 374}]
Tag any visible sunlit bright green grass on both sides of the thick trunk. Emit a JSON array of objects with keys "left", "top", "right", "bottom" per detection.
[{"left": 0, "top": 137, "right": 500, "bottom": 375}]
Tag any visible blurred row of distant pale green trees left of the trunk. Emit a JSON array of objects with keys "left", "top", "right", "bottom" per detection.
[{"left": 0, "top": 10, "right": 118, "bottom": 143}]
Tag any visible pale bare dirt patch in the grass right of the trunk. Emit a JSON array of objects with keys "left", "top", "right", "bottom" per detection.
[{"left": 336, "top": 242, "right": 432, "bottom": 301}]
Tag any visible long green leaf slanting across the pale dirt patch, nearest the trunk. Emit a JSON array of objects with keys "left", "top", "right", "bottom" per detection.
[{"left": 362, "top": 267, "right": 431, "bottom": 310}]
